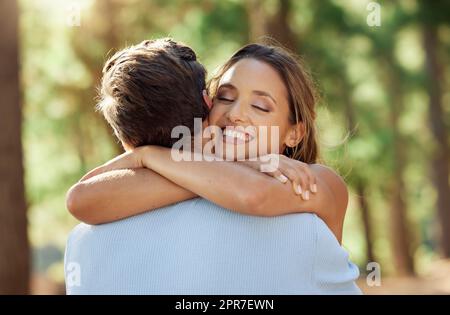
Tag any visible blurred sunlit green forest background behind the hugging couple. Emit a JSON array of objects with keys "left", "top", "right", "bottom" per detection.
[{"left": 0, "top": 0, "right": 450, "bottom": 294}]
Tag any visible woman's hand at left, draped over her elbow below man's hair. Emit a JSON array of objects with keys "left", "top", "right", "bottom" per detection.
[{"left": 80, "top": 146, "right": 147, "bottom": 182}]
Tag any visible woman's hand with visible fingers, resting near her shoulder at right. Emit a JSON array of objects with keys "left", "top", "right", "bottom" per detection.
[{"left": 240, "top": 154, "right": 317, "bottom": 200}]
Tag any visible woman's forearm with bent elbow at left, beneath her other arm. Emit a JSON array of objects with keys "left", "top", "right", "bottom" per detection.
[{"left": 66, "top": 168, "right": 197, "bottom": 224}]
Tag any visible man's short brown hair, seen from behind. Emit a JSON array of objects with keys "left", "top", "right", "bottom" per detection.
[{"left": 97, "top": 38, "right": 208, "bottom": 147}]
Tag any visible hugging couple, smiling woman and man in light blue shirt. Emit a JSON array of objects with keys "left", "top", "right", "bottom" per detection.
[{"left": 65, "top": 39, "right": 360, "bottom": 295}]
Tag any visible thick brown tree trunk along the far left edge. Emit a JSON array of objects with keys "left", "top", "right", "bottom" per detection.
[{"left": 0, "top": 0, "right": 30, "bottom": 294}]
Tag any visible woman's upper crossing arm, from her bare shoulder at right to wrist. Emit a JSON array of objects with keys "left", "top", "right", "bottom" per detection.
[{"left": 133, "top": 146, "right": 348, "bottom": 241}]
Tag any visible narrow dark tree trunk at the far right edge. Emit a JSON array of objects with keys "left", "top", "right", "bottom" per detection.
[{"left": 423, "top": 25, "right": 450, "bottom": 258}]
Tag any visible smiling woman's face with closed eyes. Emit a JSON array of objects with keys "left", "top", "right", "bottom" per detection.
[{"left": 209, "top": 58, "right": 298, "bottom": 159}]
